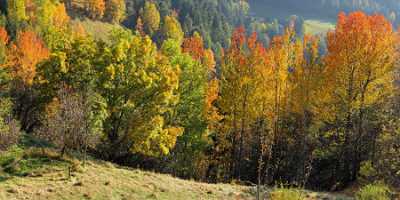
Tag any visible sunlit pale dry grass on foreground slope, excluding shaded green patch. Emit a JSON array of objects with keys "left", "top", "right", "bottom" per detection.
[{"left": 0, "top": 158, "right": 252, "bottom": 200}]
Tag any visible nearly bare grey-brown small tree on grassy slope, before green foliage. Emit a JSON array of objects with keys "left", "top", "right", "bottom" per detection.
[{"left": 35, "top": 84, "right": 105, "bottom": 159}]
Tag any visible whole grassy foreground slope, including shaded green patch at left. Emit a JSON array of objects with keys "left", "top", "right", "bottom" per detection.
[{"left": 0, "top": 148, "right": 351, "bottom": 200}]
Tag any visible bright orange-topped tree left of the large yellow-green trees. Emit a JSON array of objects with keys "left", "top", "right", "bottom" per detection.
[{"left": 7, "top": 31, "right": 50, "bottom": 131}]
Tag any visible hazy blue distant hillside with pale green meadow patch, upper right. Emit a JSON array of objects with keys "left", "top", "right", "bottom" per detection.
[{"left": 249, "top": 0, "right": 400, "bottom": 34}]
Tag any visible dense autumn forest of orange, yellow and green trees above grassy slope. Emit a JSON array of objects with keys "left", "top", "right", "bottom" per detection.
[{"left": 0, "top": 0, "right": 400, "bottom": 197}]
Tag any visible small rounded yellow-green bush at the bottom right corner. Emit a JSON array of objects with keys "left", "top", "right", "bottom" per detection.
[{"left": 356, "top": 184, "right": 390, "bottom": 200}]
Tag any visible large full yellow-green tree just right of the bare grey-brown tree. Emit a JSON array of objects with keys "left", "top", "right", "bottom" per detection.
[{"left": 98, "top": 32, "right": 183, "bottom": 159}]
